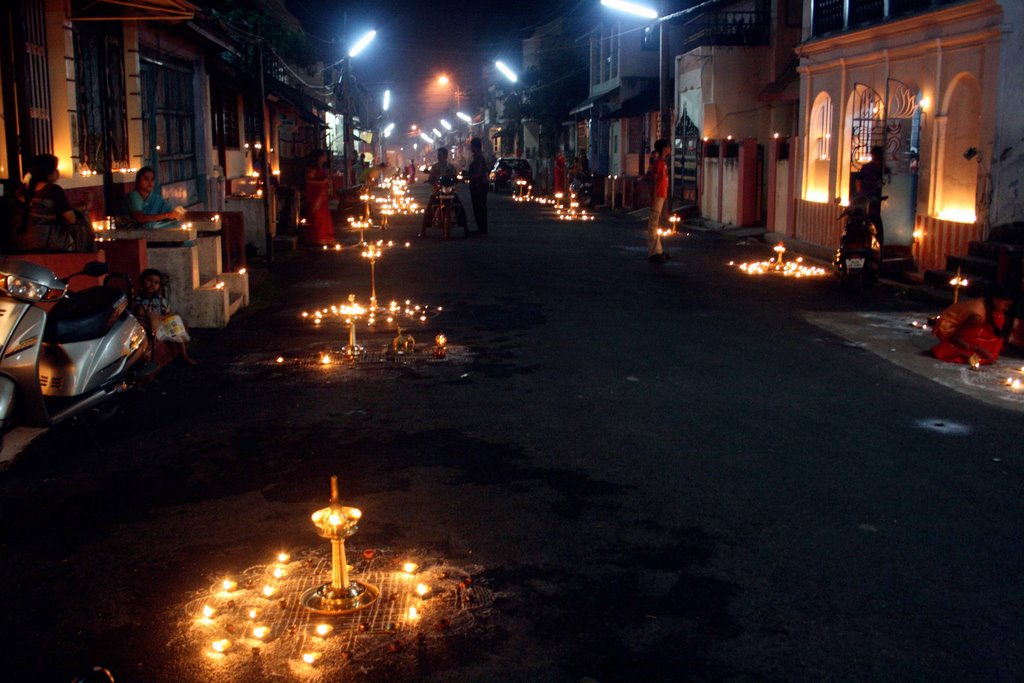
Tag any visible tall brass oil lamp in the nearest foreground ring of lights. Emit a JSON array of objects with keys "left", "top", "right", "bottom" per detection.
[{"left": 302, "top": 476, "right": 380, "bottom": 614}]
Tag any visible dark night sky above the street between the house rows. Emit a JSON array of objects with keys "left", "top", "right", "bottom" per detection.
[{"left": 287, "top": 0, "right": 599, "bottom": 126}]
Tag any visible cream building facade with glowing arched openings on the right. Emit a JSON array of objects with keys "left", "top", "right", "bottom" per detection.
[{"left": 790, "top": 0, "right": 1004, "bottom": 269}]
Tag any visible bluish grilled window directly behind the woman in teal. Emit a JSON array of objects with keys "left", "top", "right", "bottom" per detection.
[{"left": 141, "top": 56, "right": 199, "bottom": 204}]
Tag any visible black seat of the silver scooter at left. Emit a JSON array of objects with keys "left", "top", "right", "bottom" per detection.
[{"left": 43, "top": 287, "right": 128, "bottom": 344}]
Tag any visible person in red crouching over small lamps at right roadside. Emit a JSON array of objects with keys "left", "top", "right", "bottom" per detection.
[{"left": 932, "top": 288, "right": 1013, "bottom": 366}]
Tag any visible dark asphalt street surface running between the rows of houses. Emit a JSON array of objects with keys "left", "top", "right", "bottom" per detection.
[{"left": 0, "top": 184, "right": 1024, "bottom": 681}]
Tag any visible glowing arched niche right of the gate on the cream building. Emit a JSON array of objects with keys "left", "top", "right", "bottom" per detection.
[{"left": 936, "top": 74, "right": 988, "bottom": 223}]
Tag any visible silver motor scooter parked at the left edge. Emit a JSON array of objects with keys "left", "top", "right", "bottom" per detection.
[{"left": 0, "top": 258, "right": 147, "bottom": 448}]
